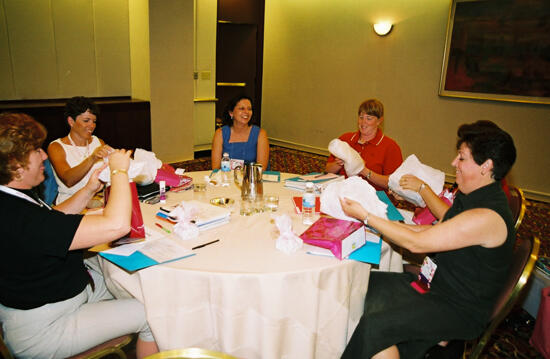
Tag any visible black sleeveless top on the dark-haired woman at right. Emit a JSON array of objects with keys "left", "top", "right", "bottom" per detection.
[{"left": 432, "top": 182, "right": 516, "bottom": 325}]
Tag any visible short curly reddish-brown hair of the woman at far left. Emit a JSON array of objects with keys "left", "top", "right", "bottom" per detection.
[{"left": 0, "top": 113, "right": 47, "bottom": 185}]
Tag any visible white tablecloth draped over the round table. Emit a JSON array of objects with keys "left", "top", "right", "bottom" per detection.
[{"left": 102, "top": 172, "right": 402, "bottom": 359}]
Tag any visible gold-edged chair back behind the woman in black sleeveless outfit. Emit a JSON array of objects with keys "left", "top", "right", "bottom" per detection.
[{"left": 463, "top": 237, "right": 540, "bottom": 359}]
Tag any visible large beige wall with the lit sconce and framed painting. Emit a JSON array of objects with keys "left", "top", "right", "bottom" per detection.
[{"left": 262, "top": 0, "right": 550, "bottom": 199}]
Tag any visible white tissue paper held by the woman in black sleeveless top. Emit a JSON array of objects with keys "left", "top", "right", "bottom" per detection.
[{"left": 321, "top": 176, "right": 388, "bottom": 222}]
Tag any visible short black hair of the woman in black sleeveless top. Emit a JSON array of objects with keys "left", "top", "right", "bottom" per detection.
[{"left": 456, "top": 121, "right": 516, "bottom": 181}]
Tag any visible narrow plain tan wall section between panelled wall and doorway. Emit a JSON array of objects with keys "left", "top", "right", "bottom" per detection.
[{"left": 149, "top": 0, "right": 194, "bottom": 162}]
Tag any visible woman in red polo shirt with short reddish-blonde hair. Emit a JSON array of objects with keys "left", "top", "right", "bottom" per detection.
[{"left": 326, "top": 99, "right": 403, "bottom": 191}]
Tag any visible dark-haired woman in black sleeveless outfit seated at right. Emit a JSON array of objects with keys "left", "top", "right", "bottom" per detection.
[{"left": 341, "top": 122, "right": 516, "bottom": 359}]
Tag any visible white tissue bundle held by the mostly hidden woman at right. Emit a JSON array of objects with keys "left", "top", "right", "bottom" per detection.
[{"left": 388, "top": 155, "right": 445, "bottom": 207}]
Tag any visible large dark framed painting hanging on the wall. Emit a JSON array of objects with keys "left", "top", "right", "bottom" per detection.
[{"left": 439, "top": 0, "right": 550, "bottom": 104}]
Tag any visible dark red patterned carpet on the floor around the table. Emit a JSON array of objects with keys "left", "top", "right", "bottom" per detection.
[{"left": 169, "top": 146, "right": 550, "bottom": 359}]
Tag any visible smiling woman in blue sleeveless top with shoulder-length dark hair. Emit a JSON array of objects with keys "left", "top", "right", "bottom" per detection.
[{"left": 212, "top": 95, "right": 269, "bottom": 169}]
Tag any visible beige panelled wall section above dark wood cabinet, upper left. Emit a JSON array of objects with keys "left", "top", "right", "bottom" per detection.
[{"left": 0, "top": 0, "right": 131, "bottom": 100}]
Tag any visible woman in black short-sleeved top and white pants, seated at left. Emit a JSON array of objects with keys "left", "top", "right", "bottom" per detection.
[{"left": 0, "top": 114, "right": 158, "bottom": 358}]
